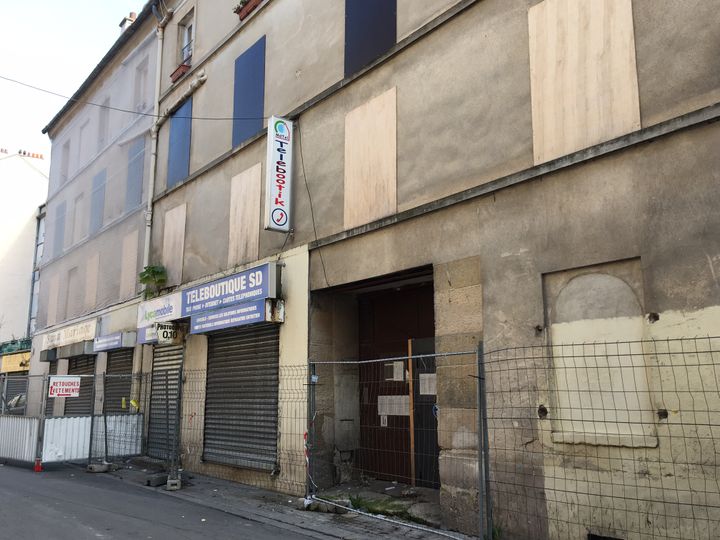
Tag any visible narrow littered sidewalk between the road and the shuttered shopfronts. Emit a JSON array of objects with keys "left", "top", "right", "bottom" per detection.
[{"left": 109, "top": 465, "right": 467, "bottom": 540}]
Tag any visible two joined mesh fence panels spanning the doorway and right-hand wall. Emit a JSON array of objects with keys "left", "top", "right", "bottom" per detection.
[{"left": 307, "top": 337, "right": 720, "bottom": 539}]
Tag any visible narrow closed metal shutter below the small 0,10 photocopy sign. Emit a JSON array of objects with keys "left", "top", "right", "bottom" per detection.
[{"left": 147, "top": 345, "right": 183, "bottom": 459}]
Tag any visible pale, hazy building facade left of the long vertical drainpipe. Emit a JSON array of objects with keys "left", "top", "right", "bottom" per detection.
[{"left": 28, "top": 4, "right": 157, "bottom": 416}]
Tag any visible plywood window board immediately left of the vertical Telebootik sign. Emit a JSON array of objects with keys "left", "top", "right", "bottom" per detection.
[{"left": 228, "top": 163, "right": 262, "bottom": 267}]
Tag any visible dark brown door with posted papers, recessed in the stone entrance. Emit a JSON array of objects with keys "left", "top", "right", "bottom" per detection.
[{"left": 358, "top": 280, "right": 439, "bottom": 487}]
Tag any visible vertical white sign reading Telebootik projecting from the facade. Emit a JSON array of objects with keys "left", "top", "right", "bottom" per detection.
[{"left": 265, "top": 116, "right": 294, "bottom": 232}]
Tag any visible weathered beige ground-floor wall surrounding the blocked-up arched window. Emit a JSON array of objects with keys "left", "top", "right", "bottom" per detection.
[{"left": 310, "top": 120, "right": 720, "bottom": 538}]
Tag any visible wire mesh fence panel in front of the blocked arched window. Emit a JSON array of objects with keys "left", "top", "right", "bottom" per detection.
[{"left": 484, "top": 337, "right": 720, "bottom": 539}]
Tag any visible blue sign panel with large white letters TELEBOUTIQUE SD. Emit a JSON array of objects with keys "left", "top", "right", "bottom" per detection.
[{"left": 182, "top": 263, "right": 278, "bottom": 317}]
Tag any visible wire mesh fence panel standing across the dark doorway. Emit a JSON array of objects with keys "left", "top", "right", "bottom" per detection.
[{"left": 308, "top": 343, "right": 479, "bottom": 534}]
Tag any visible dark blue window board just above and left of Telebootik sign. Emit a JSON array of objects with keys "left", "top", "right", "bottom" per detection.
[{"left": 233, "top": 36, "right": 265, "bottom": 147}]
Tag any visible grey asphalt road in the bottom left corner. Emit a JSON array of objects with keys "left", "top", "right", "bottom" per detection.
[{"left": 0, "top": 465, "right": 316, "bottom": 540}]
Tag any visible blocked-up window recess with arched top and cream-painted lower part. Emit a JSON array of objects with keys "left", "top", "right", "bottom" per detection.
[{"left": 545, "top": 261, "right": 657, "bottom": 446}]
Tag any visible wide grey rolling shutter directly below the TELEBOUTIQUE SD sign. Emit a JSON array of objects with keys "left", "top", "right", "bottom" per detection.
[{"left": 203, "top": 324, "right": 280, "bottom": 471}]
